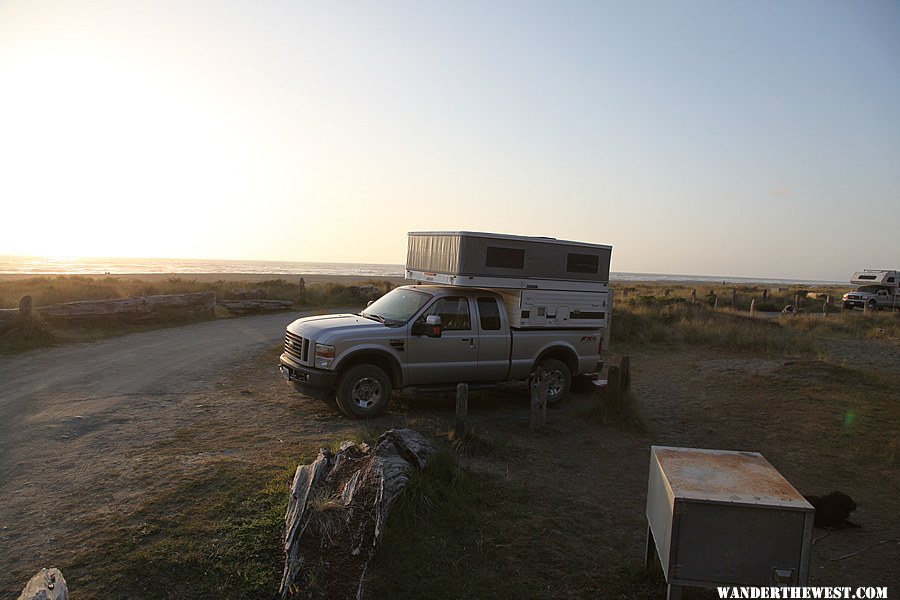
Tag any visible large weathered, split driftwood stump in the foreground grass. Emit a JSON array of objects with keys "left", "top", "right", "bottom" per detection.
[{"left": 279, "top": 429, "right": 434, "bottom": 599}]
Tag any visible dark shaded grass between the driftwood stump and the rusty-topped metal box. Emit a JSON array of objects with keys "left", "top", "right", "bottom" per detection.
[{"left": 366, "top": 448, "right": 661, "bottom": 599}]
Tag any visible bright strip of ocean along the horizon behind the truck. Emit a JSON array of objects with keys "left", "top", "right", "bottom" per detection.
[{"left": 0, "top": 256, "right": 845, "bottom": 285}]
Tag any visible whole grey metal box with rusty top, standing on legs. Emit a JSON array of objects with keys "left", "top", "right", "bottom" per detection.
[{"left": 647, "top": 446, "right": 814, "bottom": 597}]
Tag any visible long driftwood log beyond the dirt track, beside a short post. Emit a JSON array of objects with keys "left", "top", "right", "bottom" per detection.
[{"left": 34, "top": 291, "right": 216, "bottom": 322}]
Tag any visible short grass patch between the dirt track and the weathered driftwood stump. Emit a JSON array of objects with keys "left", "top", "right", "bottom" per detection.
[{"left": 60, "top": 461, "right": 302, "bottom": 599}]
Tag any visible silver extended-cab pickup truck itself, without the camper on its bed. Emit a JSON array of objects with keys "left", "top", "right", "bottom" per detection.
[{"left": 280, "top": 285, "right": 608, "bottom": 418}]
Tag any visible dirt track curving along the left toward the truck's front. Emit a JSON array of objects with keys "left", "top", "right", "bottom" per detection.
[{"left": 0, "top": 313, "right": 312, "bottom": 597}]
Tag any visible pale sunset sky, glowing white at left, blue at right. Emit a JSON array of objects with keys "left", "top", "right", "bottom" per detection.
[{"left": 0, "top": 0, "right": 900, "bottom": 281}]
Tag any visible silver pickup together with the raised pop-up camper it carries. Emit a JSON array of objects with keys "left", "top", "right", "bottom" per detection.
[{"left": 280, "top": 231, "right": 612, "bottom": 418}]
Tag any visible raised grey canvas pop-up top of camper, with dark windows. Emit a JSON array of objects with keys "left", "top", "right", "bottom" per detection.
[{"left": 406, "top": 231, "right": 612, "bottom": 291}]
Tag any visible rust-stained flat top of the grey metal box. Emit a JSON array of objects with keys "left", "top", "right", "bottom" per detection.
[{"left": 651, "top": 446, "right": 813, "bottom": 511}]
